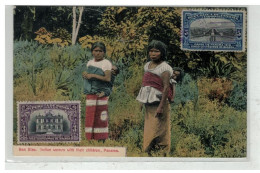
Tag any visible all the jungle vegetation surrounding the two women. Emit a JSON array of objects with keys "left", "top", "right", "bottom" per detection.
[{"left": 13, "top": 6, "right": 247, "bottom": 157}]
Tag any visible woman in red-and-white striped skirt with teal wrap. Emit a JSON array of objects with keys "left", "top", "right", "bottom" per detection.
[{"left": 82, "top": 42, "right": 112, "bottom": 140}]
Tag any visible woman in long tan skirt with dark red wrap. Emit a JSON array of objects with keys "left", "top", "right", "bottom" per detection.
[{"left": 137, "top": 40, "right": 173, "bottom": 155}]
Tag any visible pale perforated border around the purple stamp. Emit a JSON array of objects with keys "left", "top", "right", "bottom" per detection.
[{"left": 16, "top": 100, "right": 81, "bottom": 144}]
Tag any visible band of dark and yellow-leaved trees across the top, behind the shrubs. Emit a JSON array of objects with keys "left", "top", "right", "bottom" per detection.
[{"left": 14, "top": 6, "right": 247, "bottom": 82}]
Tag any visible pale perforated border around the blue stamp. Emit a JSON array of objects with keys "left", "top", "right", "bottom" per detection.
[{"left": 180, "top": 7, "right": 248, "bottom": 52}]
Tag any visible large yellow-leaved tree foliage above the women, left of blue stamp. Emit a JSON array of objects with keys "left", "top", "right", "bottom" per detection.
[{"left": 95, "top": 7, "right": 185, "bottom": 64}]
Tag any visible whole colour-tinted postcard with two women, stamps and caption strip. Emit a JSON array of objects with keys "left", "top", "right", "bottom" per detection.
[{"left": 11, "top": 6, "right": 248, "bottom": 159}]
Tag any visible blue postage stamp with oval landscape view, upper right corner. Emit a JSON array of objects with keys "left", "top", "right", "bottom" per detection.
[{"left": 181, "top": 10, "right": 246, "bottom": 51}]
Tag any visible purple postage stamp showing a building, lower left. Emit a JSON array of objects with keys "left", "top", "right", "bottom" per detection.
[{"left": 17, "top": 101, "right": 80, "bottom": 143}]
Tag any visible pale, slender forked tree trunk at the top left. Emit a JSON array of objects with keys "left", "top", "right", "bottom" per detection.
[{"left": 71, "top": 7, "right": 84, "bottom": 45}]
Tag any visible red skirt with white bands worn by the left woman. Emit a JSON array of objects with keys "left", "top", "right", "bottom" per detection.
[{"left": 85, "top": 95, "right": 108, "bottom": 140}]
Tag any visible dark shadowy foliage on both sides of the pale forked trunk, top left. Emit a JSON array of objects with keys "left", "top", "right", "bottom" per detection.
[{"left": 14, "top": 6, "right": 106, "bottom": 40}]
